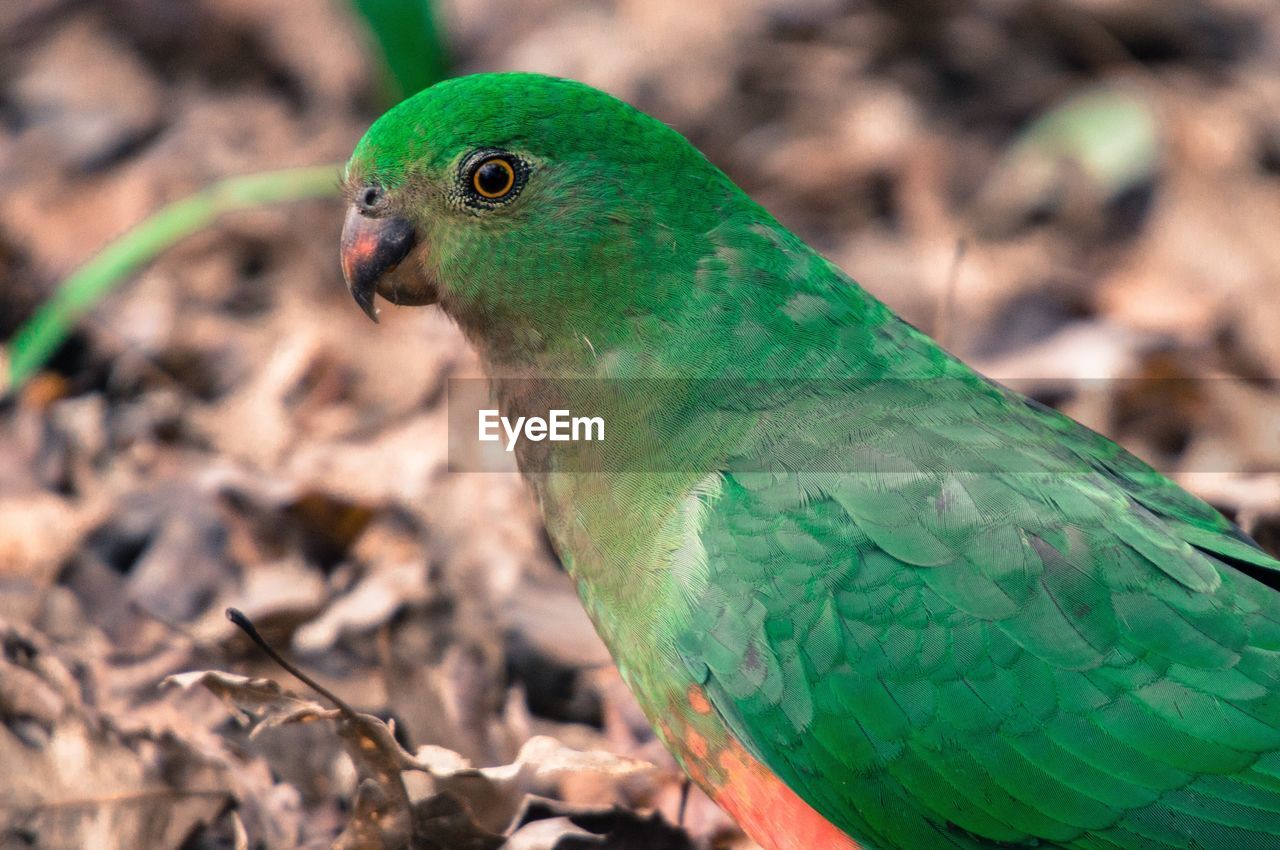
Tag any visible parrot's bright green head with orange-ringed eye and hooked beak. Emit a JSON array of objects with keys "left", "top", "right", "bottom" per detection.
[{"left": 342, "top": 74, "right": 754, "bottom": 360}]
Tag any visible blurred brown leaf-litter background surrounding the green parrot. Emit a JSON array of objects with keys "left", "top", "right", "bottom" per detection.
[{"left": 0, "top": 0, "right": 1280, "bottom": 850}]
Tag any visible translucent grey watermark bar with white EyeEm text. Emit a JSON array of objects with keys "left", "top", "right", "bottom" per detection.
[{"left": 447, "top": 376, "right": 1280, "bottom": 477}]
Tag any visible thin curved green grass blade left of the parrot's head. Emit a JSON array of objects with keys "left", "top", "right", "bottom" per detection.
[{"left": 0, "top": 164, "right": 340, "bottom": 389}]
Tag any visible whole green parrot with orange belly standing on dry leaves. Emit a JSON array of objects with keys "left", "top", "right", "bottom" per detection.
[{"left": 342, "top": 74, "right": 1280, "bottom": 850}]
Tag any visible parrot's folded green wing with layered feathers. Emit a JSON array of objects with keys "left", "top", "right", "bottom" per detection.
[{"left": 681, "top": 386, "right": 1280, "bottom": 850}]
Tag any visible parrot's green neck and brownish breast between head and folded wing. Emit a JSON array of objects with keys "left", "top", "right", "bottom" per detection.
[{"left": 445, "top": 213, "right": 973, "bottom": 629}]
